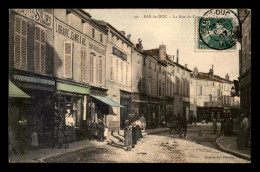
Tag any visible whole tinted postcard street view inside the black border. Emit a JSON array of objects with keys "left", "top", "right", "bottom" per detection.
[{"left": 8, "top": 9, "right": 251, "bottom": 164}]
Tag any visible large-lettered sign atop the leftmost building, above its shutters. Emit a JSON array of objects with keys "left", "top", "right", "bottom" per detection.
[{"left": 14, "top": 9, "right": 53, "bottom": 29}]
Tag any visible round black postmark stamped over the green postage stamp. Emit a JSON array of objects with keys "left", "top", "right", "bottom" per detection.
[{"left": 198, "top": 9, "right": 241, "bottom": 50}]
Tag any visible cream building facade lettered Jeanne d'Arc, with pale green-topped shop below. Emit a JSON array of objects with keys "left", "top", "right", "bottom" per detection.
[{"left": 54, "top": 9, "right": 109, "bottom": 140}]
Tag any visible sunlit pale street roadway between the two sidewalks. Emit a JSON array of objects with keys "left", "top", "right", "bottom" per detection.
[{"left": 44, "top": 125, "right": 250, "bottom": 163}]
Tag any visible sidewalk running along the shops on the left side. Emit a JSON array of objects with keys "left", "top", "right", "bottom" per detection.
[{"left": 9, "top": 128, "right": 169, "bottom": 163}]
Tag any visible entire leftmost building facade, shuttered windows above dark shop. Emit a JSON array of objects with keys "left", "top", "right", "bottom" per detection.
[{"left": 8, "top": 9, "right": 56, "bottom": 150}]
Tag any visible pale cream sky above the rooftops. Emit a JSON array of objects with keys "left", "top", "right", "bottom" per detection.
[{"left": 85, "top": 9, "right": 240, "bottom": 80}]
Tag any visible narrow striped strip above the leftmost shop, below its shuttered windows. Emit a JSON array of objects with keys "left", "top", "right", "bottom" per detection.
[{"left": 13, "top": 74, "right": 55, "bottom": 86}]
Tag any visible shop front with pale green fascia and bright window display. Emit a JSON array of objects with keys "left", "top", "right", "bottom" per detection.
[{"left": 55, "top": 81, "right": 90, "bottom": 141}]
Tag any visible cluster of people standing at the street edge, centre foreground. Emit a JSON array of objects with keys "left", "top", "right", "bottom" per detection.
[{"left": 124, "top": 114, "right": 146, "bottom": 151}]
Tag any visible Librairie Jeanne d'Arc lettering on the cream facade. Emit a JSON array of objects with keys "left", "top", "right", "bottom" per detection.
[{"left": 54, "top": 18, "right": 87, "bottom": 46}]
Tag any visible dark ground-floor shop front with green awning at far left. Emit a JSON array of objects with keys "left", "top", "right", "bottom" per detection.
[{"left": 8, "top": 70, "right": 56, "bottom": 151}]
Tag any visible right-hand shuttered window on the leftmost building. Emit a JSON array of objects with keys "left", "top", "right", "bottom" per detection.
[{"left": 34, "top": 26, "right": 46, "bottom": 73}]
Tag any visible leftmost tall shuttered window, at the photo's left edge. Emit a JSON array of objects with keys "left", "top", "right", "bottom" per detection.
[{"left": 14, "top": 16, "right": 27, "bottom": 69}]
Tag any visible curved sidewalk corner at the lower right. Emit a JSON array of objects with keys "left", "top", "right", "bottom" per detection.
[{"left": 216, "top": 135, "right": 251, "bottom": 160}]
